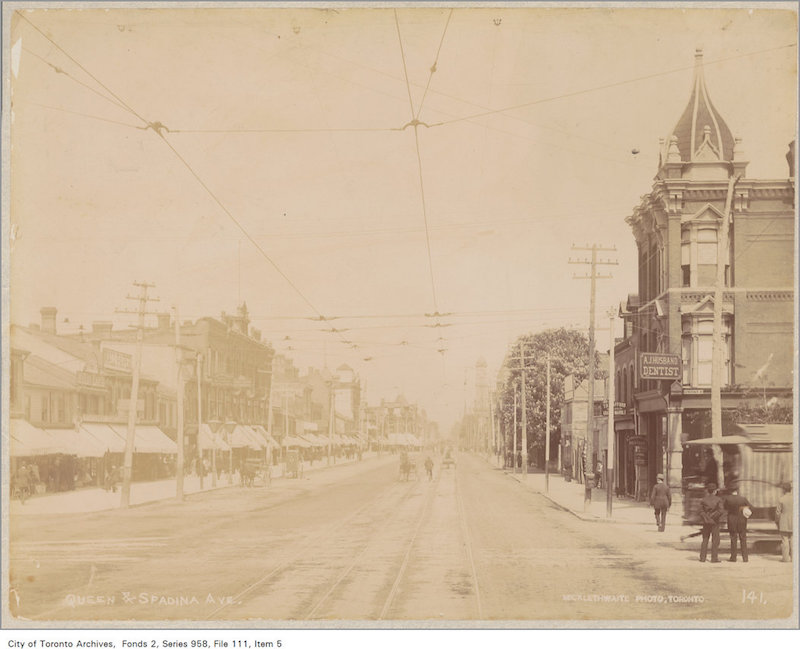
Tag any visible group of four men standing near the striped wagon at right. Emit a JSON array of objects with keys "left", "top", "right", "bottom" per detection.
[{"left": 650, "top": 474, "right": 794, "bottom": 563}]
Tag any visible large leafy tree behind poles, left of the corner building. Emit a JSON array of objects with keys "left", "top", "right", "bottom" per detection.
[{"left": 499, "top": 327, "right": 600, "bottom": 464}]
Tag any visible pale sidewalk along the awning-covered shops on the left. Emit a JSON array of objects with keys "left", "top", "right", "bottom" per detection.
[{"left": 9, "top": 452, "right": 385, "bottom": 516}]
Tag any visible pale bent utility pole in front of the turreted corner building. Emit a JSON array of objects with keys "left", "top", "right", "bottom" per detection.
[{"left": 711, "top": 175, "right": 739, "bottom": 488}]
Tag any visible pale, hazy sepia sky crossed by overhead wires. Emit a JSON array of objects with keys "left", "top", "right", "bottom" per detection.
[{"left": 4, "top": 3, "right": 797, "bottom": 432}]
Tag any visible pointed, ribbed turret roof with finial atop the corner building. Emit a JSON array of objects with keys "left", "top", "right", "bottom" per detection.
[{"left": 663, "top": 48, "right": 734, "bottom": 162}]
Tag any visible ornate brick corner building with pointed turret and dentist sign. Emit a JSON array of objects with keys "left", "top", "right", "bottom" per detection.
[{"left": 615, "top": 50, "right": 795, "bottom": 496}]
